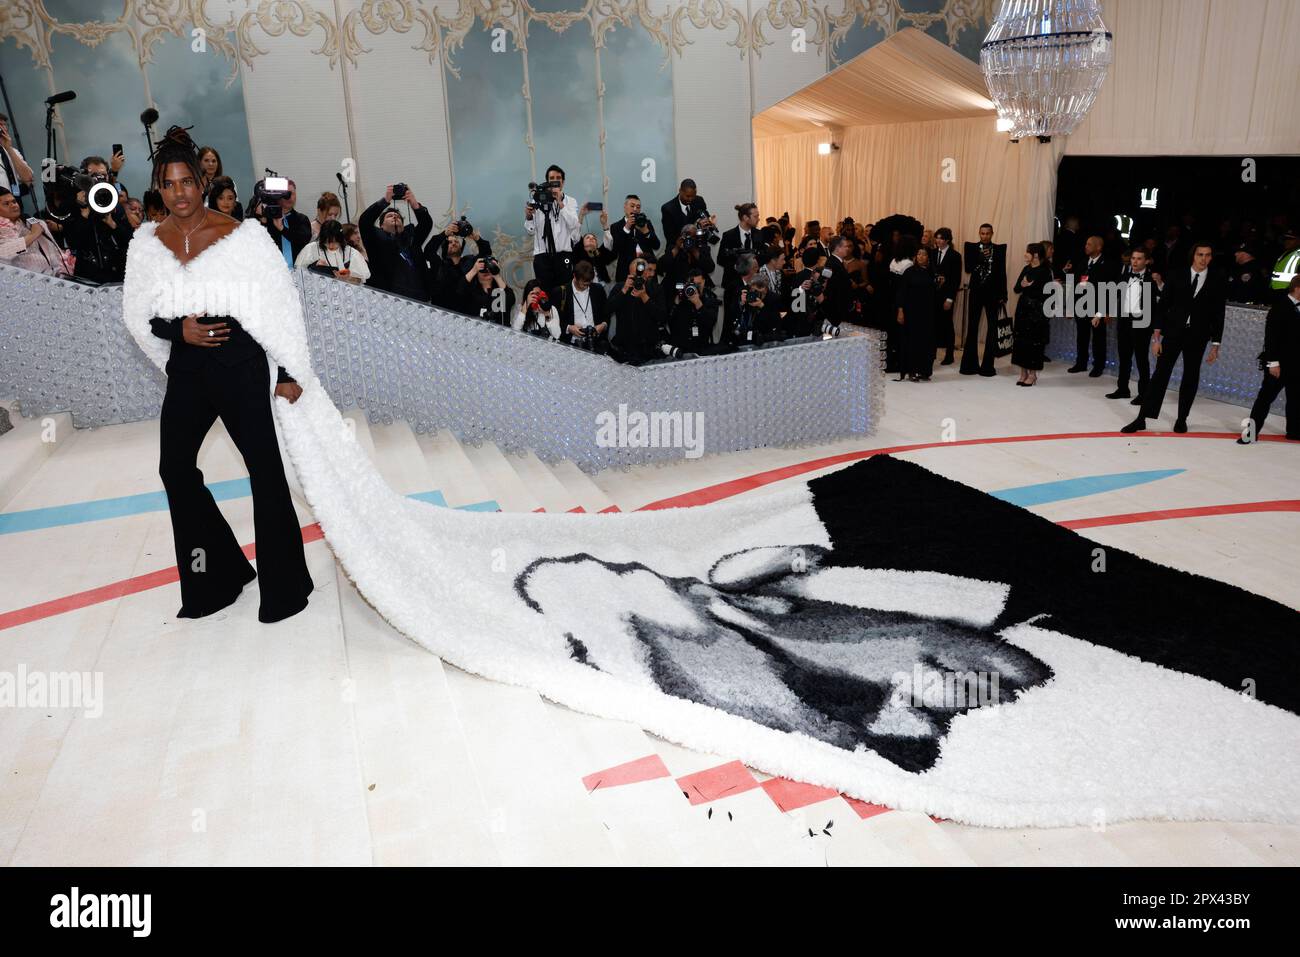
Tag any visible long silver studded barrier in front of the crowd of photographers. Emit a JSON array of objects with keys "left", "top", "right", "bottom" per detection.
[{"left": 0, "top": 264, "right": 884, "bottom": 472}]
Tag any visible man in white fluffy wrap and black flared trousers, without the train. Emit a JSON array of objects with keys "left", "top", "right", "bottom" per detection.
[{"left": 122, "top": 126, "right": 313, "bottom": 622}]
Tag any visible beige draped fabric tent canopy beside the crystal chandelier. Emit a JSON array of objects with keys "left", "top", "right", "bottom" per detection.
[{"left": 754, "top": 29, "right": 1065, "bottom": 308}]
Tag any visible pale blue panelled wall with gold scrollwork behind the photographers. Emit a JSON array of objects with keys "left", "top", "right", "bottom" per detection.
[{"left": 0, "top": 0, "right": 993, "bottom": 281}]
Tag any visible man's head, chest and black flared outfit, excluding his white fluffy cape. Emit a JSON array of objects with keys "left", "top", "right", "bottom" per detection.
[{"left": 143, "top": 126, "right": 313, "bottom": 622}]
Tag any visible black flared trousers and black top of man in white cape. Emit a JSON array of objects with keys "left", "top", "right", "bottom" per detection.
[{"left": 150, "top": 316, "right": 313, "bottom": 622}]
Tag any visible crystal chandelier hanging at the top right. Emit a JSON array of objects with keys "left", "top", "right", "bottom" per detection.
[{"left": 979, "top": 0, "right": 1113, "bottom": 139}]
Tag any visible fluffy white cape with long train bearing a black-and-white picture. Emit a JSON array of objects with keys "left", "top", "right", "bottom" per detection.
[{"left": 124, "top": 221, "right": 1300, "bottom": 827}]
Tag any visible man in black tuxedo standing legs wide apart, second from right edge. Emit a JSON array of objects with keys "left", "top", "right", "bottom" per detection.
[{"left": 1121, "top": 243, "right": 1227, "bottom": 433}]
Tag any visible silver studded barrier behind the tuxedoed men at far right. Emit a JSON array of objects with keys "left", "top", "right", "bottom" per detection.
[{"left": 1047, "top": 303, "right": 1286, "bottom": 415}]
